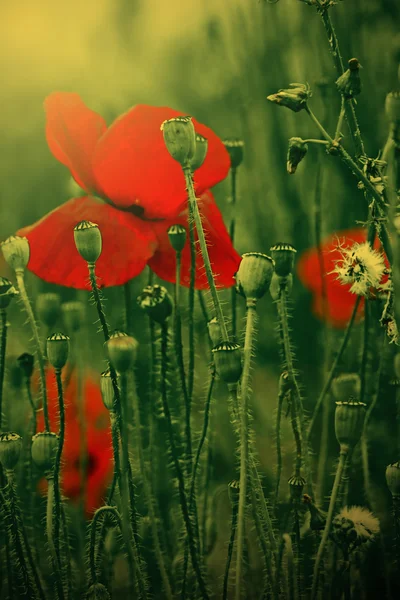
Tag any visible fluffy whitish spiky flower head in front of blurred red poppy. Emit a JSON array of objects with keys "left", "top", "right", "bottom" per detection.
[{"left": 331, "top": 242, "right": 385, "bottom": 296}]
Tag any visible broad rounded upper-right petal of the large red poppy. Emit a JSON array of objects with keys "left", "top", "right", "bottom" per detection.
[{"left": 93, "top": 105, "right": 230, "bottom": 218}]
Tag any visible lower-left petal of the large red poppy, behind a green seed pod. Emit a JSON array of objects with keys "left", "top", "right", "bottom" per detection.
[{"left": 18, "top": 197, "right": 156, "bottom": 289}]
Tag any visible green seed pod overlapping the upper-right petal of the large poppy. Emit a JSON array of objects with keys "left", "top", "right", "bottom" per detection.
[{"left": 161, "top": 117, "right": 196, "bottom": 167}]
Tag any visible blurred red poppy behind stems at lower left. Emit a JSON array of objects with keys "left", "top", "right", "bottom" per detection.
[{"left": 38, "top": 367, "right": 113, "bottom": 514}]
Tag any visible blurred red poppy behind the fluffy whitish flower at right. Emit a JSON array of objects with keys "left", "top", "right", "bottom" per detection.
[{"left": 297, "top": 228, "right": 388, "bottom": 328}]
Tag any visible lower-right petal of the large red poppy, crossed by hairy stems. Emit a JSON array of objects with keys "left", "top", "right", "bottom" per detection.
[{"left": 149, "top": 190, "right": 240, "bottom": 290}]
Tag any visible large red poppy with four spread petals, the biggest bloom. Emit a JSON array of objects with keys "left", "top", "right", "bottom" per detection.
[{"left": 18, "top": 92, "right": 240, "bottom": 289}]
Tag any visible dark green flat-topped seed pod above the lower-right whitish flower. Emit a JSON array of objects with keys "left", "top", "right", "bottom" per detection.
[{"left": 335, "top": 400, "right": 366, "bottom": 452}]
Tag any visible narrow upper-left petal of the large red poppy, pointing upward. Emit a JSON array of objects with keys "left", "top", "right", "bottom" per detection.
[{"left": 45, "top": 92, "right": 107, "bottom": 192}]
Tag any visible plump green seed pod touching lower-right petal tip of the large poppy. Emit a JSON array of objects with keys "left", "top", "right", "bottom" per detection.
[{"left": 235, "top": 252, "right": 274, "bottom": 300}]
